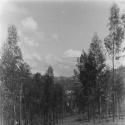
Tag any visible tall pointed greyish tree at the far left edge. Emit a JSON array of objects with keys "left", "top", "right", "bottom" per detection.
[{"left": 0, "top": 25, "right": 23, "bottom": 125}]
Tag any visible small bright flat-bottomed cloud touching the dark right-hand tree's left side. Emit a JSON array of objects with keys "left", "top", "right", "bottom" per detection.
[{"left": 64, "top": 49, "right": 81, "bottom": 57}]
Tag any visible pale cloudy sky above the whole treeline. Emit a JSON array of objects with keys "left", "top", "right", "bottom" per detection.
[{"left": 0, "top": 0, "right": 125, "bottom": 76}]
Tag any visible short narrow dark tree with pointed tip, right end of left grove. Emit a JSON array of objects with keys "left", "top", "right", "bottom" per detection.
[{"left": 43, "top": 66, "right": 54, "bottom": 125}]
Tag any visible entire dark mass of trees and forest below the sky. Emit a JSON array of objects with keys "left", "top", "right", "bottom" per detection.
[{"left": 0, "top": 4, "right": 125, "bottom": 125}]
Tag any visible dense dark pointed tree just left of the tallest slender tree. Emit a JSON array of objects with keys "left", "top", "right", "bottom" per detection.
[{"left": 77, "top": 34, "right": 106, "bottom": 119}]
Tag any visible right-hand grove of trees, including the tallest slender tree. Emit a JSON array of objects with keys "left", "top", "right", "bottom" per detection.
[{"left": 75, "top": 4, "right": 125, "bottom": 121}]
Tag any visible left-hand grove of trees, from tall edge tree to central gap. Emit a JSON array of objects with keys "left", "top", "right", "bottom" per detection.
[{"left": 0, "top": 25, "right": 65, "bottom": 125}]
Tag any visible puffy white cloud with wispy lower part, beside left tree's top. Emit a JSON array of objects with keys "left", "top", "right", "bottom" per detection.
[{"left": 18, "top": 16, "right": 41, "bottom": 48}]
